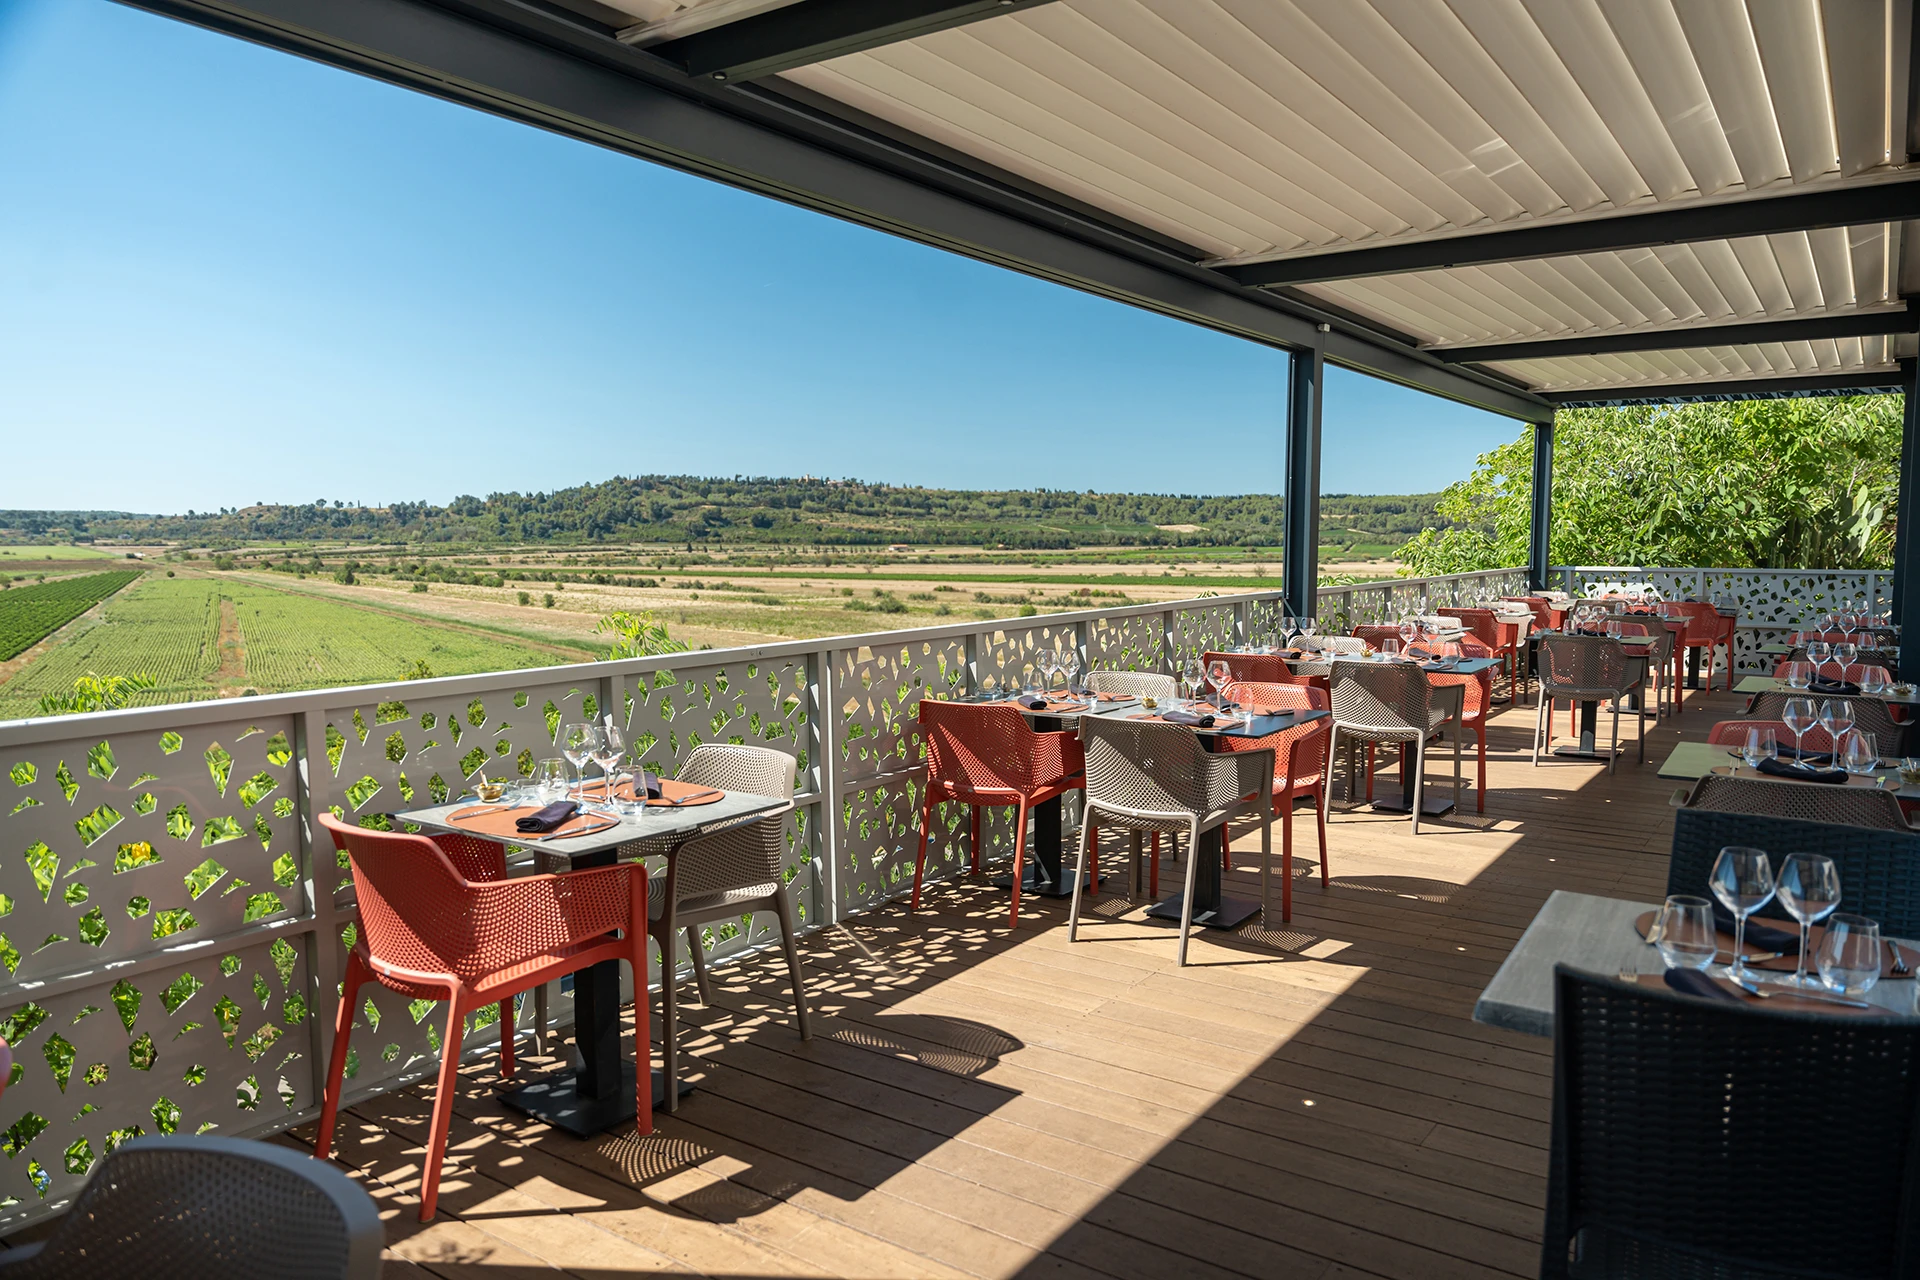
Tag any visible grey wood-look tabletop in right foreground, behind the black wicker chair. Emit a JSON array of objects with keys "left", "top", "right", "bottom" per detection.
[{"left": 1473, "top": 889, "right": 1920, "bottom": 1036}]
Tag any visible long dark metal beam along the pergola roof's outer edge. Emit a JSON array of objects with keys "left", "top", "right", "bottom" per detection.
[{"left": 121, "top": 0, "right": 1551, "bottom": 422}]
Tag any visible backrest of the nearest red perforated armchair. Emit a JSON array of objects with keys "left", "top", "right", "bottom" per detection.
[{"left": 321, "top": 814, "right": 480, "bottom": 973}]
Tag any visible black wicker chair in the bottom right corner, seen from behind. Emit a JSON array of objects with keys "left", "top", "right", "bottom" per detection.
[{"left": 1540, "top": 965, "right": 1920, "bottom": 1280}]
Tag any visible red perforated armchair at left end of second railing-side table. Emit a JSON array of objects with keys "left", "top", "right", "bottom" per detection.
[{"left": 912, "top": 699, "right": 1087, "bottom": 929}]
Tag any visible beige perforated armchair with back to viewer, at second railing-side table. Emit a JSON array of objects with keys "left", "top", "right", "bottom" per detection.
[{"left": 1068, "top": 716, "right": 1273, "bottom": 965}]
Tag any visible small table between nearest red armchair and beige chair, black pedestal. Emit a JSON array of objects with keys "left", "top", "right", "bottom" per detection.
[{"left": 394, "top": 791, "right": 789, "bottom": 1138}]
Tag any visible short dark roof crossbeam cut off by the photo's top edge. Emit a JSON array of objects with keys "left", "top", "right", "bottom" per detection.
[{"left": 651, "top": 0, "right": 1048, "bottom": 81}]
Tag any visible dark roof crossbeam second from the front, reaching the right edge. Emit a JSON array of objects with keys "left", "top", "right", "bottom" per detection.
[{"left": 1219, "top": 178, "right": 1920, "bottom": 288}]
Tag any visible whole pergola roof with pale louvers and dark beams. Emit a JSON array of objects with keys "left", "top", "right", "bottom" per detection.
[{"left": 140, "top": 0, "right": 1920, "bottom": 418}]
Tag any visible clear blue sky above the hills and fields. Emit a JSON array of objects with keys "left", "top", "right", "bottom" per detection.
[{"left": 0, "top": 0, "right": 1521, "bottom": 512}]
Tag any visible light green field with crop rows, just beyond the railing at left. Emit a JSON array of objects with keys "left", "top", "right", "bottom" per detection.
[{"left": 0, "top": 578, "right": 568, "bottom": 720}]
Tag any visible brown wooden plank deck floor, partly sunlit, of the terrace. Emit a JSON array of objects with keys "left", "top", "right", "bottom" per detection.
[{"left": 303, "top": 695, "right": 1736, "bottom": 1280}]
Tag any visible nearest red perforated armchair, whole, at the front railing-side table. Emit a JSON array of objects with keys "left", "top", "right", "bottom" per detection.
[{"left": 313, "top": 814, "right": 653, "bottom": 1222}]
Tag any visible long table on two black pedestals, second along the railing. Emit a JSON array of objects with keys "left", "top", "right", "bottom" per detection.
[{"left": 970, "top": 695, "right": 1327, "bottom": 929}]
